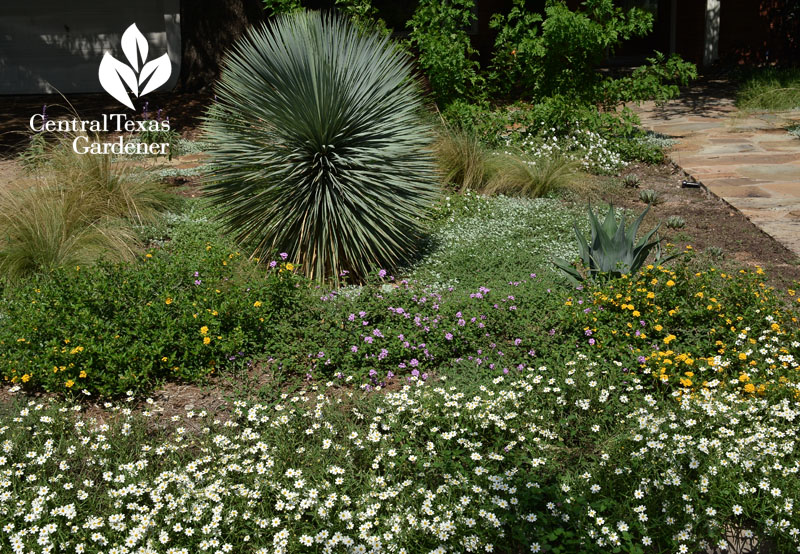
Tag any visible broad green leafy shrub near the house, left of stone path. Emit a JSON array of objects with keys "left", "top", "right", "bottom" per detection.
[{"left": 490, "top": 0, "right": 697, "bottom": 108}]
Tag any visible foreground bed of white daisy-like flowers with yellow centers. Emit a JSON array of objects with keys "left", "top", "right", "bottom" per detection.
[{"left": 0, "top": 342, "right": 800, "bottom": 554}]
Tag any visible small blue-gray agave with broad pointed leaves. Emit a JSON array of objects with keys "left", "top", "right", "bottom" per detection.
[{"left": 554, "top": 206, "right": 675, "bottom": 284}]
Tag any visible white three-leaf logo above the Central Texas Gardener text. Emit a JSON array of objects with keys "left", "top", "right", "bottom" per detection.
[{"left": 98, "top": 23, "right": 172, "bottom": 110}]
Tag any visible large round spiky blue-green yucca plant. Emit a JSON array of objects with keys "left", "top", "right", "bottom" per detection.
[{"left": 204, "top": 12, "right": 436, "bottom": 280}]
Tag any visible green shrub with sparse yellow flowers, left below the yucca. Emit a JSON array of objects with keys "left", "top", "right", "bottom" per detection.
[{"left": 0, "top": 205, "right": 303, "bottom": 395}]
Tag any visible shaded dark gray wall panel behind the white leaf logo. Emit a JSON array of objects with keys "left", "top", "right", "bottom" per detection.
[{"left": 0, "top": 0, "right": 181, "bottom": 94}]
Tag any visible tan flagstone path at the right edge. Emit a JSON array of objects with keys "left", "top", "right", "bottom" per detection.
[{"left": 637, "top": 81, "right": 800, "bottom": 256}]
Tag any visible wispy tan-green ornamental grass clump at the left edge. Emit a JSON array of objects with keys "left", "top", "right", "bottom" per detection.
[{"left": 0, "top": 135, "right": 169, "bottom": 282}]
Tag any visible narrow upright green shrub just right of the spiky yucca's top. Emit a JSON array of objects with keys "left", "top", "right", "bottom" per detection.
[{"left": 406, "top": 0, "right": 481, "bottom": 107}]
